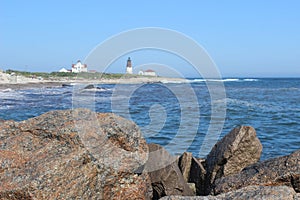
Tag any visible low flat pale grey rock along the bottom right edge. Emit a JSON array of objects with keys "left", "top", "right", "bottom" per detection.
[{"left": 160, "top": 186, "right": 299, "bottom": 200}]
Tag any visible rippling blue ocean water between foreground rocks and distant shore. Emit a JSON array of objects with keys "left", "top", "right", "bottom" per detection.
[{"left": 0, "top": 78, "right": 300, "bottom": 160}]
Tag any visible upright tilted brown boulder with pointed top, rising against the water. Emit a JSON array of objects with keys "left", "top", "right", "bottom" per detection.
[{"left": 203, "top": 126, "right": 262, "bottom": 195}]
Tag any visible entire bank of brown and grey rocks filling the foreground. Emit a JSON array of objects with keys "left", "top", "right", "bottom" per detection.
[{"left": 0, "top": 109, "right": 300, "bottom": 200}]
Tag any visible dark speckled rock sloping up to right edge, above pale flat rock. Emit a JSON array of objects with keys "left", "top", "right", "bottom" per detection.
[{"left": 214, "top": 150, "right": 300, "bottom": 194}]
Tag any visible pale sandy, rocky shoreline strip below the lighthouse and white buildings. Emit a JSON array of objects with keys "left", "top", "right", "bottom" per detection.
[{"left": 0, "top": 70, "right": 186, "bottom": 90}]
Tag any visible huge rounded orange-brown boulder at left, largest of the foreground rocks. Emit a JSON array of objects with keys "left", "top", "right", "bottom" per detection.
[{"left": 0, "top": 109, "right": 152, "bottom": 199}]
